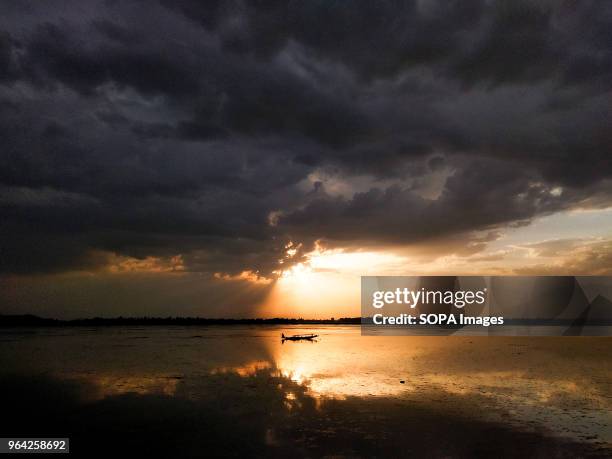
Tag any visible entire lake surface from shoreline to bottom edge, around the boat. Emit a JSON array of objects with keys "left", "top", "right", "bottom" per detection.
[{"left": 0, "top": 326, "right": 612, "bottom": 458}]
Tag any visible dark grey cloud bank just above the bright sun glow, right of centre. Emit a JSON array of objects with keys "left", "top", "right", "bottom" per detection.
[{"left": 278, "top": 158, "right": 583, "bottom": 245}]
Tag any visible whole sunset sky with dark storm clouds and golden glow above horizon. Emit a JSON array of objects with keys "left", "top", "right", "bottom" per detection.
[{"left": 0, "top": 0, "right": 612, "bottom": 317}]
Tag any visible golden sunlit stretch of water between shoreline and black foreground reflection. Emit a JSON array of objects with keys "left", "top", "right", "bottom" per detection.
[{"left": 0, "top": 326, "right": 612, "bottom": 450}]
